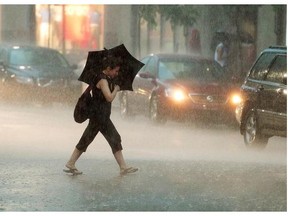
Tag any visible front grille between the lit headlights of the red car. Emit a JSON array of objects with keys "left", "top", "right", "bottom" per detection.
[{"left": 189, "top": 94, "right": 227, "bottom": 104}]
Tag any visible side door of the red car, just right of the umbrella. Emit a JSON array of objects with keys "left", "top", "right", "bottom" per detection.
[{"left": 133, "top": 56, "right": 156, "bottom": 112}]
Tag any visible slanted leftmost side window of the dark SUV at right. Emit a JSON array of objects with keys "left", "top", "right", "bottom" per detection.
[{"left": 249, "top": 53, "right": 275, "bottom": 80}]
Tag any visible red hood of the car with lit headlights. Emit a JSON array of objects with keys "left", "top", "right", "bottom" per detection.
[{"left": 164, "top": 80, "right": 233, "bottom": 95}]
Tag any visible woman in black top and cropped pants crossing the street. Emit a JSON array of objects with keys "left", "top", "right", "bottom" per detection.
[{"left": 64, "top": 56, "right": 138, "bottom": 175}]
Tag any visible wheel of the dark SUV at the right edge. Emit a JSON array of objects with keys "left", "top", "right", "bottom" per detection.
[{"left": 244, "top": 111, "right": 268, "bottom": 149}]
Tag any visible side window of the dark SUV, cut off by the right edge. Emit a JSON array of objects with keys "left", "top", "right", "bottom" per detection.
[{"left": 266, "top": 55, "right": 287, "bottom": 83}]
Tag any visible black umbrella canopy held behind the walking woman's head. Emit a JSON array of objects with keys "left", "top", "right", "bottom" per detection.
[{"left": 79, "top": 44, "right": 144, "bottom": 91}]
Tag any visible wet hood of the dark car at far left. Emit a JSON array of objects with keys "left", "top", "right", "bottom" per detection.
[{"left": 10, "top": 65, "right": 73, "bottom": 79}]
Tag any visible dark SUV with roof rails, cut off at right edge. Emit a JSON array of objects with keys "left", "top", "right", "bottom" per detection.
[{"left": 236, "top": 47, "right": 287, "bottom": 148}]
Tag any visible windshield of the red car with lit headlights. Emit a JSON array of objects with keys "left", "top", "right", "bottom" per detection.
[{"left": 159, "top": 59, "right": 223, "bottom": 82}]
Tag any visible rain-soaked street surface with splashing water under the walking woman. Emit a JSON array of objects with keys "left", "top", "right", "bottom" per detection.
[{"left": 0, "top": 102, "right": 287, "bottom": 212}]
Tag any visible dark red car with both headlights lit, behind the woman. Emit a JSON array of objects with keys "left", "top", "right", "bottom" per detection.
[{"left": 119, "top": 54, "right": 239, "bottom": 123}]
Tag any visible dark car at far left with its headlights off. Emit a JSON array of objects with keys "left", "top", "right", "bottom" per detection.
[{"left": 0, "top": 45, "right": 82, "bottom": 102}]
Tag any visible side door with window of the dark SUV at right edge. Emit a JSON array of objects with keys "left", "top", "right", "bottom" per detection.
[{"left": 262, "top": 55, "right": 287, "bottom": 130}]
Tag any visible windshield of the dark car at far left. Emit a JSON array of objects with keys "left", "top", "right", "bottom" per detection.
[{"left": 9, "top": 49, "right": 69, "bottom": 67}]
